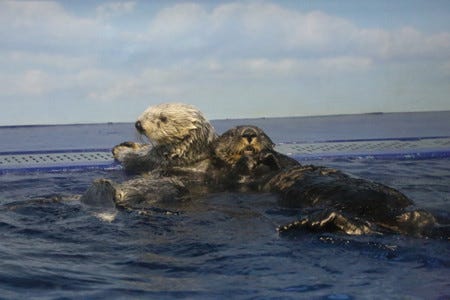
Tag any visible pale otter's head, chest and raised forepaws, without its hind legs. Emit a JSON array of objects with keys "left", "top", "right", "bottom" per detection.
[{"left": 112, "top": 103, "right": 217, "bottom": 174}]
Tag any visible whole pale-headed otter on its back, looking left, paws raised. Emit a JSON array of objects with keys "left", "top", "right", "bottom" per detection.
[{"left": 81, "top": 103, "right": 217, "bottom": 209}]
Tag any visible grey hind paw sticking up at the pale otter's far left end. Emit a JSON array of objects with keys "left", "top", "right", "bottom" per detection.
[{"left": 80, "top": 179, "right": 116, "bottom": 208}]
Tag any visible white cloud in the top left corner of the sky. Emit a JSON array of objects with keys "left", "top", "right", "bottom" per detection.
[{"left": 0, "top": 1, "right": 108, "bottom": 53}]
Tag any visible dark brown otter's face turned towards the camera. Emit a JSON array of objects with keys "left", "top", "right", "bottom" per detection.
[{"left": 214, "top": 125, "right": 274, "bottom": 164}]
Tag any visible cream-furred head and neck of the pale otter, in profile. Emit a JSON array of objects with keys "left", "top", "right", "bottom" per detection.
[{"left": 135, "top": 103, "right": 216, "bottom": 157}]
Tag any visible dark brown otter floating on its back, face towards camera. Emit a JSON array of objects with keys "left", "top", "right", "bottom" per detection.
[{"left": 214, "top": 126, "right": 448, "bottom": 238}]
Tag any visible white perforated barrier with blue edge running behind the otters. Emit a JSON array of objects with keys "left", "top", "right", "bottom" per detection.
[{"left": 0, "top": 137, "right": 450, "bottom": 174}]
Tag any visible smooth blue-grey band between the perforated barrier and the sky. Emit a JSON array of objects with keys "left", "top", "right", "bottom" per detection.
[{"left": 0, "top": 111, "right": 450, "bottom": 152}]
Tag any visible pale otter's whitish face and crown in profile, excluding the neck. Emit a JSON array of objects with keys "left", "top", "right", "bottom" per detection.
[{"left": 135, "top": 103, "right": 212, "bottom": 144}]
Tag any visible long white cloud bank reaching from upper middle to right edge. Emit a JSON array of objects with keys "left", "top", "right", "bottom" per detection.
[{"left": 139, "top": 2, "right": 450, "bottom": 60}]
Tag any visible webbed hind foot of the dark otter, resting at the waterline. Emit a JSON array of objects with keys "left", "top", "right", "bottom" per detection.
[{"left": 277, "top": 210, "right": 379, "bottom": 235}]
